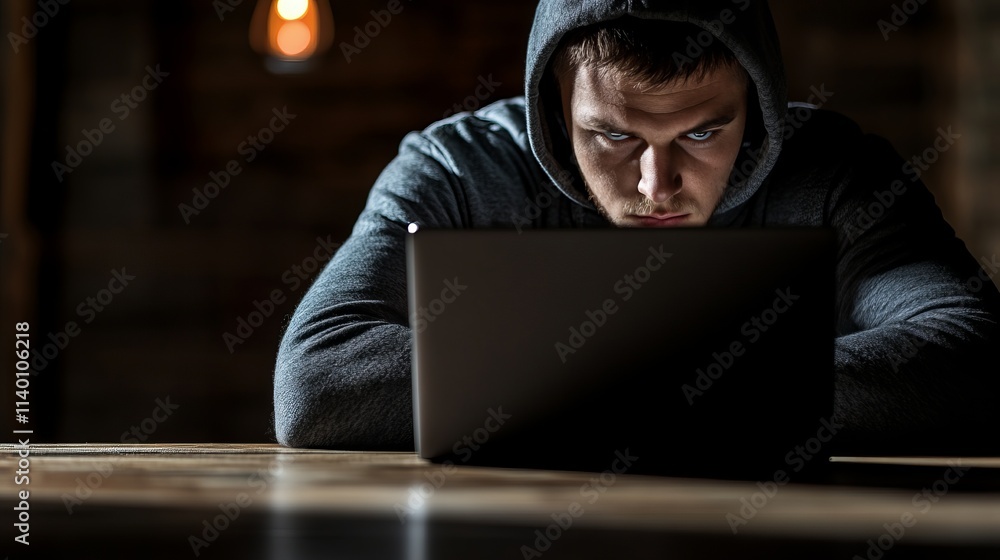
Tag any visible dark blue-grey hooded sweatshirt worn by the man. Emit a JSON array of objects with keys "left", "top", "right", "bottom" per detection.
[{"left": 274, "top": 0, "right": 1000, "bottom": 455}]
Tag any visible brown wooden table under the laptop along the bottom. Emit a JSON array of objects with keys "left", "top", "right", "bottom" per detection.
[{"left": 0, "top": 444, "right": 1000, "bottom": 560}]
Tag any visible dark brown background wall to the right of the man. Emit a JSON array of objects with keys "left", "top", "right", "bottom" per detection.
[{"left": 772, "top": 0, "right": 1000, "bottom": 282}]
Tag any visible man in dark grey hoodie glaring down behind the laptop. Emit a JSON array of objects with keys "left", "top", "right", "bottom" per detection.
[{"left": 274, "top": 0, "right": 1000, "bottom": 454}]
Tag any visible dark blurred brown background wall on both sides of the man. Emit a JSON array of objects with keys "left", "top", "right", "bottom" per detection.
[{"left": 0, "top": 0, "right": 1000, "bottom": 443}]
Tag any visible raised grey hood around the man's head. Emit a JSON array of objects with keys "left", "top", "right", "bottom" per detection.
[{"left": 525, "top": 0, "right": 788, "bottom": 216}]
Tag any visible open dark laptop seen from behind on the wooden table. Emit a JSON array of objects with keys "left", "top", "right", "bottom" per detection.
[{"left": 406, "top": 227, "right": 836, "bottom": 480}]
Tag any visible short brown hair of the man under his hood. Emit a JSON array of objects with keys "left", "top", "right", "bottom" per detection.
[{"left": 552, "top": 16, "right": 746, "bottom": 88}]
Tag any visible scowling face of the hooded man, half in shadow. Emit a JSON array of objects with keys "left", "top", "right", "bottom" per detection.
[{"left": 559, "top": 61, "right": 747, "bottom": 227}]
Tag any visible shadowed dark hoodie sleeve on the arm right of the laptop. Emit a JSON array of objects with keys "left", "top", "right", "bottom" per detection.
[{"left": 828, "top": 130, "right": 1000, "bottom": 455}]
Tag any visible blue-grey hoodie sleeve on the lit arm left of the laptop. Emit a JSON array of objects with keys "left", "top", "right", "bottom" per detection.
[{"left": 274, "top": 129, "right": 462, "bottom": 450}]
